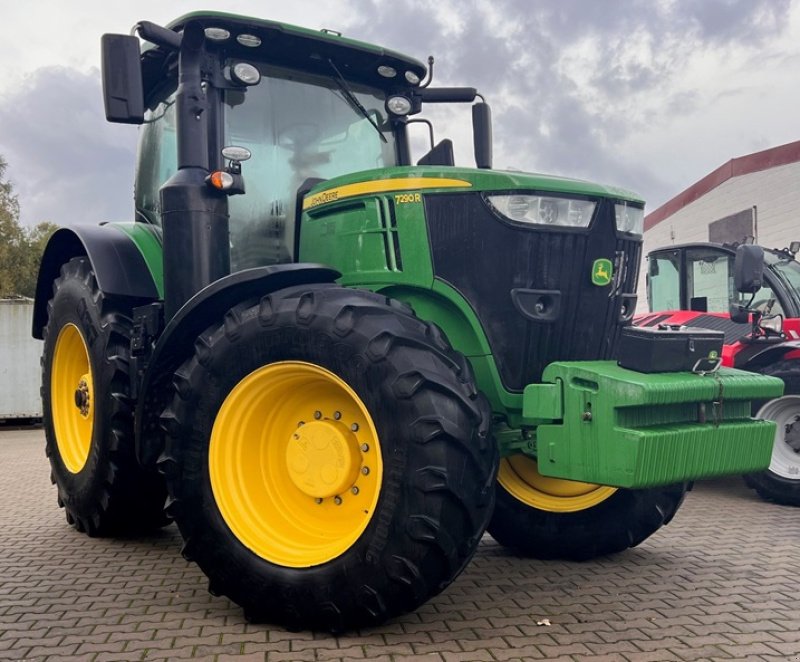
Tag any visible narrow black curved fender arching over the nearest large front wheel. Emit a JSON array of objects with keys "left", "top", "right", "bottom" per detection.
[{"left": 136, "top": 263, "right": 341, "bottom": 466}]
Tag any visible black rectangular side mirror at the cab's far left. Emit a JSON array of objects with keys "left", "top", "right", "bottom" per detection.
[{"left": 101, "top": 34, "right": 144, "bottom": 124}]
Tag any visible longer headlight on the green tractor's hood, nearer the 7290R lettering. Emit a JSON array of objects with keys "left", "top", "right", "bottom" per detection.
[{"left": 486, "top": 195, "right": 597, "bottom": 228}]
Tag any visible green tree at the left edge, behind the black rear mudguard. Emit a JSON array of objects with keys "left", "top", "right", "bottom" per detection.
[{"left": 0, "top": 156, "right": 57, "bottom": 298}]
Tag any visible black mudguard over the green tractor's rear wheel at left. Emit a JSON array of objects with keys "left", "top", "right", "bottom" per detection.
[{"left": 32, "top": 224, "right": 158, "bottom": 340}]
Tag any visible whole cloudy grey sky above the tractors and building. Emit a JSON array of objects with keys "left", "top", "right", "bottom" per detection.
[{"left": 0, "top": 0, "right": 800, "bottom": 224}]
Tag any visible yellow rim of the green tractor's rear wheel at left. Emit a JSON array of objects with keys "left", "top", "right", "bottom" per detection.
[{"left": 50, "top": 324, "right": 94, "bottom": 474}]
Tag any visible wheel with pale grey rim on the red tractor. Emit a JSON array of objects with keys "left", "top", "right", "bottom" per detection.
[{"left": 744, "top": 360, "right": 800, "bottom": 506}]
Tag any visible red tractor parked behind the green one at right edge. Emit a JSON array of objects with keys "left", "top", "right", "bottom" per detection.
[{"left": 636, "top": 242, "right": 800, "bottom": 506}]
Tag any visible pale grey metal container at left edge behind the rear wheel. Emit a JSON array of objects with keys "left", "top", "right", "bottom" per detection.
[{"left": 0, "top": 299, "right": 42, "bottom": 419}]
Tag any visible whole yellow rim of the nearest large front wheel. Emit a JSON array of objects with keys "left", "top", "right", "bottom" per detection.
[{"left": 208, "top": 361, "right": 383, "bottom": 568}]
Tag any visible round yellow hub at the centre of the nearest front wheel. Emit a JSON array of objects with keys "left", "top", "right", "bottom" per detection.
[{"left": 286, "top": 420, "right": 361, "bottom": 499}]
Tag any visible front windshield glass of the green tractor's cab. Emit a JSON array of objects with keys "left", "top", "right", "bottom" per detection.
[{"left": 223, "top": 64, "right": 397, "bottom": 271}]
